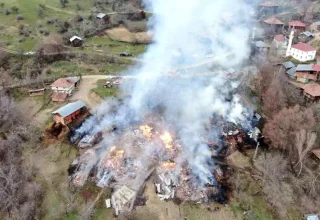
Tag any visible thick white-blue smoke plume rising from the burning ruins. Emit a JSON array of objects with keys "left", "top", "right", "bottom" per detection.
[{"left": 74, "top": 0, "right": 252, "bottom": 189}]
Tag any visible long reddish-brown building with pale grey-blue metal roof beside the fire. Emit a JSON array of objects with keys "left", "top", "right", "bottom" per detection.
[{"left": 52, "top": 100, "right": 87, "bottom": 125}]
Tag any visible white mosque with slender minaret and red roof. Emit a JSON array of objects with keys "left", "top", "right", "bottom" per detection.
[{"left": 286, "top": 31, "right": 317, "bottom": 62}]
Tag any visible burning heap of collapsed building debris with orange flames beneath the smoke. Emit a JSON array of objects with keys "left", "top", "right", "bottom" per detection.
[{"left": 71, "top": 113, "right": 262, "bottom": 215}]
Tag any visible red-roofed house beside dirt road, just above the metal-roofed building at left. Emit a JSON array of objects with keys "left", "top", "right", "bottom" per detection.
[{"left": 50, "top": 77, "right": 80, "bottom": 102}]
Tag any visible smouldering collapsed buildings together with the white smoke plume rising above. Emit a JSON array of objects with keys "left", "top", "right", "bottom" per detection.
[{"left": 67, "top": 0, "right": 255, "bottom": 215}]
